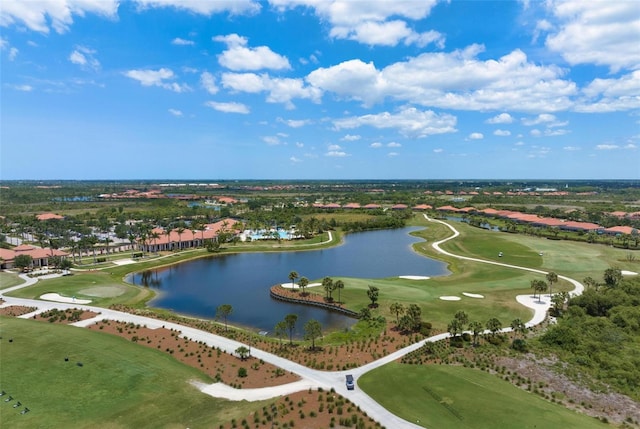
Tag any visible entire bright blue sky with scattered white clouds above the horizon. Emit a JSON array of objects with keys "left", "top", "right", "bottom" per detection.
[{"left": 0, "top": 0, "right": 640, "bottom": 180}]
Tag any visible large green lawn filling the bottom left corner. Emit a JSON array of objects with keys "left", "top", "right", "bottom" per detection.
[{"left": 0, "top": 317, "right": 262, "bottom": 428}]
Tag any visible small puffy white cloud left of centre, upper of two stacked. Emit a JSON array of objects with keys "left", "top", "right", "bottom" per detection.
[{"left": 218, "top": 34, "right": 291, "bottom": 71}]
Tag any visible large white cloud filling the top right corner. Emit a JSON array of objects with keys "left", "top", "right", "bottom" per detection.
[{"left": 545, "top": 0, "right": 640, "bottom": 72}]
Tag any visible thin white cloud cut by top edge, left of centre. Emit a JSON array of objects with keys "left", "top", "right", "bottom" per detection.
[{"left": 133, "top": 0, "right": 261, "bottom": 16}]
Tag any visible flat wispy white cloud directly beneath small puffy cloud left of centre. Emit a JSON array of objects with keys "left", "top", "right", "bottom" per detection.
[{"left": 221, "top": 73, "right": 322, "bottom": 109}]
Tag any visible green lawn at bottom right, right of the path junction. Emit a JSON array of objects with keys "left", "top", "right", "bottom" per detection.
[{"left": 358, "top": 363, "right": 608, "bottom": 429}]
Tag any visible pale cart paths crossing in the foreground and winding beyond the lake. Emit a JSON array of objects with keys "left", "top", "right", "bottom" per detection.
[{"left": 0, "top": 219, "right": 583, "bottom": 429}]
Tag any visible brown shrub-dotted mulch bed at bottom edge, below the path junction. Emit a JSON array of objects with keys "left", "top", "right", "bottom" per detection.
[{"left": 220, "top": 390, "right": 381, "bottom": 429}]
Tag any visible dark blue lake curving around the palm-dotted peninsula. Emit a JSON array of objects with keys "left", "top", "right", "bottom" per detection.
[{"left": 127, "top": 227, "right": 448, "bottom": 337}]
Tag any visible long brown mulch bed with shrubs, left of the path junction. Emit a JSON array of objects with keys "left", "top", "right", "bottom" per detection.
[{"left": 87, "top": 320, "right": 300, "bottom": 388}]
